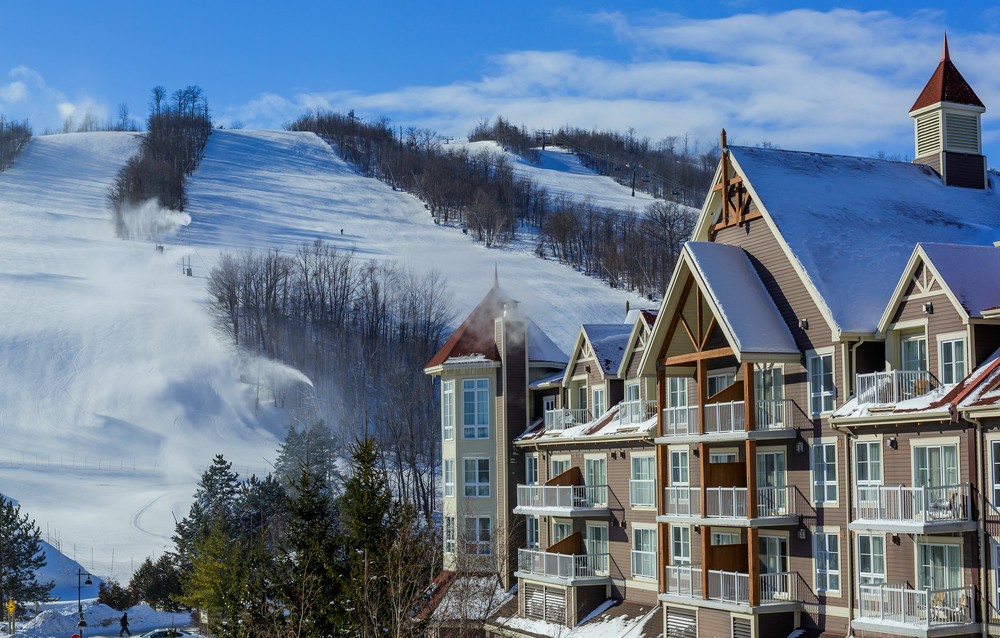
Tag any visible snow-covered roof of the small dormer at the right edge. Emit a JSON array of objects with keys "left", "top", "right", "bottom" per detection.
[{"left": 920, "top": 243, "right": 1000, "bottom": 317}]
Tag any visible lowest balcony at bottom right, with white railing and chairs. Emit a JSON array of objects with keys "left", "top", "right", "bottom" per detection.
[{"left": 851, "top": 582, "right": 979, "bottom": 636}]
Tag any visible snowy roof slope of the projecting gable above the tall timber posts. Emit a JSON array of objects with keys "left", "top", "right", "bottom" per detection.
[{"left": 684, "top": 242, "right": 799, "bottom": 353}]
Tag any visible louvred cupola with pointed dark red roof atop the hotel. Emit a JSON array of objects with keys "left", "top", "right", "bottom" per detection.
[{"left": 910, "top": 34, "right": 987, "bottom": 188}]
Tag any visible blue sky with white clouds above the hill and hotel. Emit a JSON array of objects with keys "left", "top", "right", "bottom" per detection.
[{"left": 0, "top": 0, "right": 1000, "bottom": 165}]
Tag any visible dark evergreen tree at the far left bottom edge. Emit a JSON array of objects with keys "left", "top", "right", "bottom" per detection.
[{"left": 0, "top": 496, "right": 55, "bottom": 604}]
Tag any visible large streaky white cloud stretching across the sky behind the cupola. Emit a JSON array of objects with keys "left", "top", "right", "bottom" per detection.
[{"left": 229, "top": 9, "right": 1000, "bottom": 159}]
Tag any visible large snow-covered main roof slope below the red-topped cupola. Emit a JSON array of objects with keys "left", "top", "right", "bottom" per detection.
[{"left": 729, "top": 146, "right": 1000, "bottom": 333}]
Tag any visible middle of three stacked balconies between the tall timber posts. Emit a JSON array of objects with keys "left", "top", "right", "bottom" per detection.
[{"left": 661, "top": 485, "right": 798, "bottom": 526}]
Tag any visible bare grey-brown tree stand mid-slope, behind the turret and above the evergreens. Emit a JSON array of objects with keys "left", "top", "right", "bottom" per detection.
[{"left": 208, "top": 241, "right": 454, "bottom": 515}]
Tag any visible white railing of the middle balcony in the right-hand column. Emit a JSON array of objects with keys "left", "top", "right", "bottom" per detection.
[{"left": 857, "top": 483, "right": 971, "bottom": 523}]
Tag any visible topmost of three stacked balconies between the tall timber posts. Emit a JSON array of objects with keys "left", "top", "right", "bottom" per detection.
[{"left": 662, "top": 399, "right": 795, "bottom": 443}]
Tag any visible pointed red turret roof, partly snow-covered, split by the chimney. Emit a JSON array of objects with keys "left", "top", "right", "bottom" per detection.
[{"left": 425, "top": 284, "right": 567, "bottom": 369}]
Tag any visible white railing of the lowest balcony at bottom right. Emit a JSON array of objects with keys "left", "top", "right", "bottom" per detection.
[{"left": 858, "top": 582, "right": 975, "bottom": 628}]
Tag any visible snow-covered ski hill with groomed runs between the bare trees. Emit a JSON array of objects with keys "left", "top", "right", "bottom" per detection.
[{"left": 0, "top": 130, "right": 651, "bottom": 595}]
